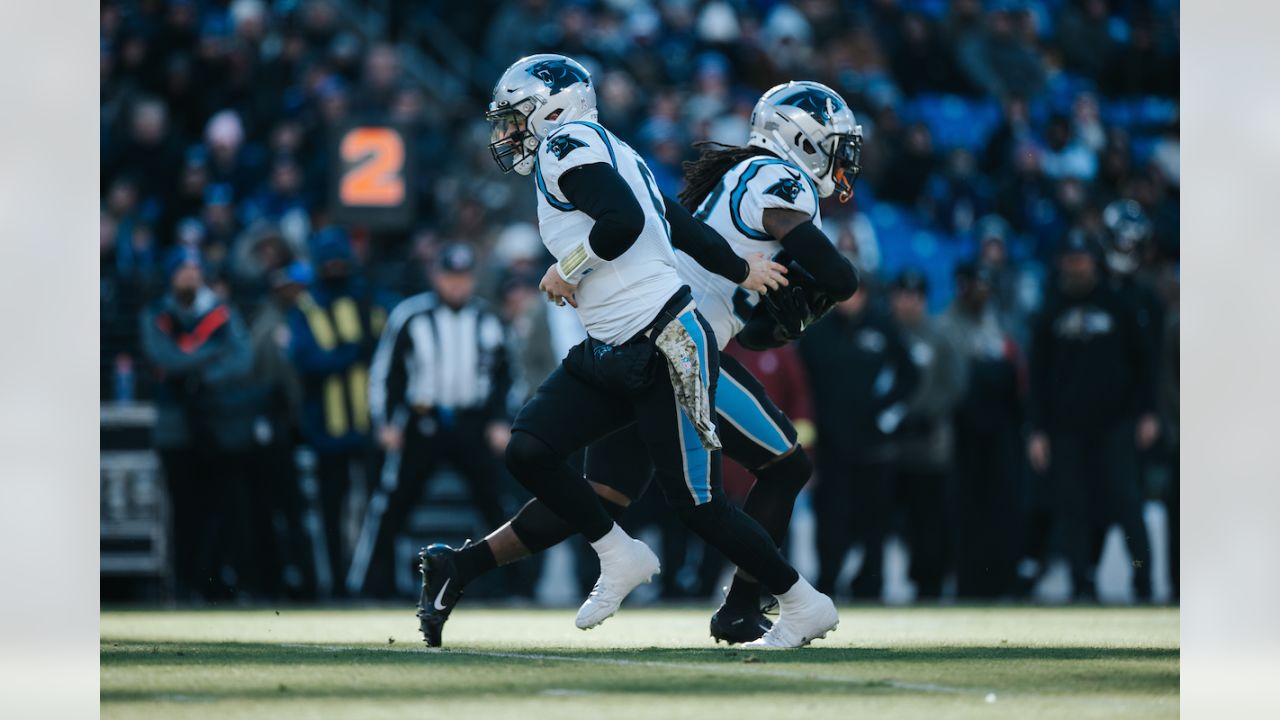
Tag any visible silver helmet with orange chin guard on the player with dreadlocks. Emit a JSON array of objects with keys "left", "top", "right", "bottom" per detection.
[{"left": 748, "top": 81, "right": 863, "bottom": 202}]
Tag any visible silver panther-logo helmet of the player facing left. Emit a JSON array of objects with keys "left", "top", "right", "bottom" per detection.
[{"left": 485, "top": 54, "right": 595, "bottom": 176}]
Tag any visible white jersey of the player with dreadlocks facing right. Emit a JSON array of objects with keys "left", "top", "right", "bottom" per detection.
[{"left": 676, "top": 155, "right": 822, "bottom": 350}]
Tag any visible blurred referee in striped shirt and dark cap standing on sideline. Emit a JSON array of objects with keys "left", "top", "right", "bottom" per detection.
[{"left": 347, "top": 243, "right": 515, "bottom": 597}]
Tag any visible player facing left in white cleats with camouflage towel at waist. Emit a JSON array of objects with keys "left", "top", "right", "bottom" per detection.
[{"left": 420, "top": 55, "right": 838, "bottom": 647}]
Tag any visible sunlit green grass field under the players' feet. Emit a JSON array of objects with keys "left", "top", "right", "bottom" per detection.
[{"left": 101, "top": 605, "right": 1179, "bottom": 720}]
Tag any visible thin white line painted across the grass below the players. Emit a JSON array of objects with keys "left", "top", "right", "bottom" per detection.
[{"left": 282, "top": 644, "right": 977, "bottom": 698}]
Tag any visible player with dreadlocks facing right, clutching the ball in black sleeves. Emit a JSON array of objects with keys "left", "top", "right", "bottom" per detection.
[{"left": 586, "top": 82, "right": 861, "bottom": 643}]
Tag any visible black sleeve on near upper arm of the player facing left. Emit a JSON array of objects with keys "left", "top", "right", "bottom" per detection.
[{"left": 559, "top": 163, "right": 644, "bottom": 260}]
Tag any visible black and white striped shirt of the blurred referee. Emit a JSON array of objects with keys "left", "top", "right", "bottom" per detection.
[{"left": 369, "top": 292, "right": 516, "bottom": 425}]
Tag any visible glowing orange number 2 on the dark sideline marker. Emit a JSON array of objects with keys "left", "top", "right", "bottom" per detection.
[{"left": 339, "top": 127, "right": 404, "bottom": 208}]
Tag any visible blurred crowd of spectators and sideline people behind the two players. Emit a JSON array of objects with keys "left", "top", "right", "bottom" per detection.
[{"left": 100, "top": 0, "right": 1179, "bottom": 600}]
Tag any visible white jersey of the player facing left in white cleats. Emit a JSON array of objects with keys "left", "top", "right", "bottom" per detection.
[{"left": 534, "top": 120, "right": 685, "bottom": 343}]
